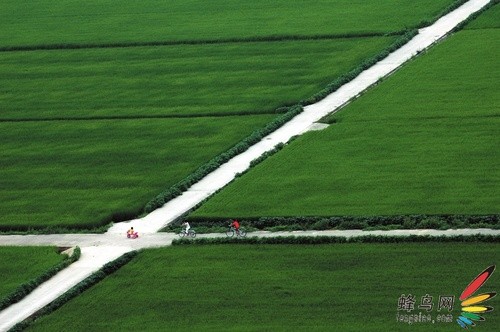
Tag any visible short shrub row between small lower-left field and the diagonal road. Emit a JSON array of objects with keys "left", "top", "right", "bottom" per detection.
[{"left": 0, "top": 247, "right": 81, "bottom": 310}]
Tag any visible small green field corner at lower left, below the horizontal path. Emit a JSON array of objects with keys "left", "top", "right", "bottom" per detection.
[{"left": 0, "top": 247, "right": 64, "bottom": 300}]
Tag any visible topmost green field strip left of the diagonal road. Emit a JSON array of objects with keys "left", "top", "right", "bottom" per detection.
[{"left": 0, "top": 0, "right": 460, "bottom": 47}]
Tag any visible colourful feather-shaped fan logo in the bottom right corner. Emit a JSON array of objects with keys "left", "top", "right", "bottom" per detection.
[{"left": 457, "top": 265, "right": 497, "bottom": 329}]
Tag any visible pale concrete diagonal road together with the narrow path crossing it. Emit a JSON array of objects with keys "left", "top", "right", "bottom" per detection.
[{"left": 0, "top": 0, "right": 492, "bottom": 331}]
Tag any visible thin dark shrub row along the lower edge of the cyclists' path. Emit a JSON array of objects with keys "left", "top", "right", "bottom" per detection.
[{"left": 172, "top": 235, "right": 500, "bottom": 245}]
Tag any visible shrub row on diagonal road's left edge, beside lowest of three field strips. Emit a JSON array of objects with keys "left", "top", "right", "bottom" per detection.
[{"left": 144, "top": 106, "right": 302, "bottom": 213}]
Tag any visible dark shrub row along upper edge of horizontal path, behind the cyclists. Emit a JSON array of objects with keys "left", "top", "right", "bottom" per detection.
[{"left": 183, "top": 214, "right": 500, "bottom": 231}]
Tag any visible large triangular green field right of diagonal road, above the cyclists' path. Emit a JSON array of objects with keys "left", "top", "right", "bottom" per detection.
[{"left": 189, "top": 29, "right": 500, "bottom": 217}]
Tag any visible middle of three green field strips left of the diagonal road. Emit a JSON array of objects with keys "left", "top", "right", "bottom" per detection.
[{"left": 0, "top": 37, "right": 396, "bottom": 119}]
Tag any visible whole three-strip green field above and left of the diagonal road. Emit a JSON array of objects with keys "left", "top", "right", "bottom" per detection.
[{"left": 0, "top": 0, "right": 486, "bottom": 231}]
